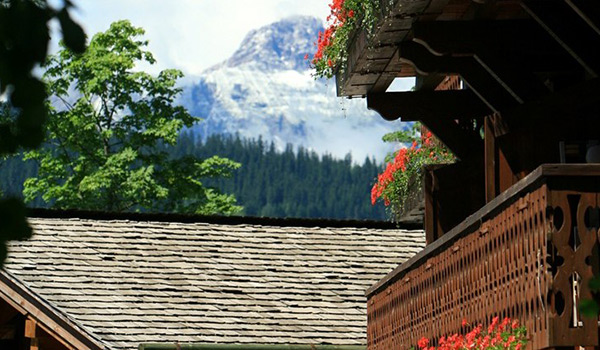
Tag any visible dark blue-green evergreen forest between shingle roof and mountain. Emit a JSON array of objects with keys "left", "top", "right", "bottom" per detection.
[{"left": 0, "top": 131, "right": 386, "bottom": 220}]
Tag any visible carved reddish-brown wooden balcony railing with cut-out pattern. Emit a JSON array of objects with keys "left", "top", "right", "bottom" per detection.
[{"left": 367, "top": 165, "right": 600, "bottom": 350}]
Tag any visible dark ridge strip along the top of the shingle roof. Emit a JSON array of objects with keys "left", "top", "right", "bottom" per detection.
[{"left": 27, "top": 208, "right": 423, "bottom": 230}]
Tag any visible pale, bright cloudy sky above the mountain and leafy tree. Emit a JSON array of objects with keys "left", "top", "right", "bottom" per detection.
[{"left": 56, "top": 0, "right": 329, "bottom": 76}]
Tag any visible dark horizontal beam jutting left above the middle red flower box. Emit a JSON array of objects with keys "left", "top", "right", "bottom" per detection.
[{"left": 367, "top": 90, "right": 490, "bottom": 121}]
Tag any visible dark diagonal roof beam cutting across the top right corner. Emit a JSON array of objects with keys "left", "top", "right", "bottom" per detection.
[{"left": 523, "top": 0, "right": 600, "bottom": 77}]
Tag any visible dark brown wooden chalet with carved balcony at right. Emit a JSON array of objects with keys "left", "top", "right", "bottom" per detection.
[{"left": 336, "top": 0, "right": 600, "bottom": 350}]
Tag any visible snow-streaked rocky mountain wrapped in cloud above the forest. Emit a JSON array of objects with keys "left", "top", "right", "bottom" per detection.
[{"left": 181, "top": 17, "right": 406, "bottom": 162}]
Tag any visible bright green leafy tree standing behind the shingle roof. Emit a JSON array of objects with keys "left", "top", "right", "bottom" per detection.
[{"left": 24, "top": 21, "right": 240, "bottom": 214}]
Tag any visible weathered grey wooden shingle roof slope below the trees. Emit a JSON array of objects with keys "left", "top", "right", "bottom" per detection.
[{"left": 2, "top": 218, "right": 425, "bottom": 349}]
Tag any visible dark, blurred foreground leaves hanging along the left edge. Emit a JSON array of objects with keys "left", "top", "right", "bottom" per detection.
[{"left": 0, "top": 0, "right": 85, "bottom": 266}]
